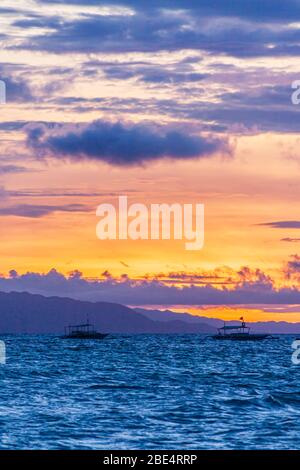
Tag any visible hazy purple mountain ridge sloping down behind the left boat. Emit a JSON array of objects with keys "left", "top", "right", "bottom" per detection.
[{"left": 0, "top": 292, "right": 215, "bottom": 334}]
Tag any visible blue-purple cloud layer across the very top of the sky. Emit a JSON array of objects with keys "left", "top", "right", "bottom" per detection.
[{"left": 14, "top": 0, "right": 300, "bottom": 58}]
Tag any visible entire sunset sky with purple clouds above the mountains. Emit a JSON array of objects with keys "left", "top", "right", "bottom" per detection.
[{"left": 0, "top": 0, "right": 300, "bottom": 321}]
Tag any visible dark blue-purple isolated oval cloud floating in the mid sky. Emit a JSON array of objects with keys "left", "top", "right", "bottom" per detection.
[{"left": 27, "top": 121, "right": 230, "bottom": 166}]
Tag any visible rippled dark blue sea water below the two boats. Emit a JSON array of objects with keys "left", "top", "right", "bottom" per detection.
[{"left": 0, "top": 335, "right": 300, "bottom": 449}]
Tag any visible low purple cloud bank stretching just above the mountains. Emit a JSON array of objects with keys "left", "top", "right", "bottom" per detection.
[{"left": 0, "top": 266, "right": 300, "bottom": 305}]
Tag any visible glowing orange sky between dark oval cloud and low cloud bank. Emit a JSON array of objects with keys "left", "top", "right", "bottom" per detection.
[{"left": 0, "top": 135, "right": 299, "bottom": 278}]
